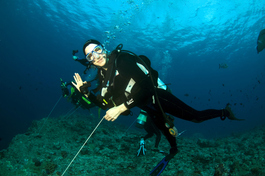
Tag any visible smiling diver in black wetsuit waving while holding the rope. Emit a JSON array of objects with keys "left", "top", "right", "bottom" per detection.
[{"left": 72, "top": 39, "right": 242, "bottom": 175}]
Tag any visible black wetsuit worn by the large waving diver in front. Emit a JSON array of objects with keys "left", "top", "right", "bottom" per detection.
[{"left": 85, "top": 51, "right": 229, "bottom": 153}]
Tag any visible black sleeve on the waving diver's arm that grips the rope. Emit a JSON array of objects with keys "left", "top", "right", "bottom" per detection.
[{"left": 117, "top": 54, "right": 154, "bottom": 109}]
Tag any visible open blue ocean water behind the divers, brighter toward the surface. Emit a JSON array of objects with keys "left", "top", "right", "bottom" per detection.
[{"left": 0, "top": 0, "right": 265, "bottom": 149}]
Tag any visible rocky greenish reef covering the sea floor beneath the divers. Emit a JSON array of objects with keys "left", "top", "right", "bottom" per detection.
[{"left": 0, "top": 115, "right": 265, "bottom": 176}]
